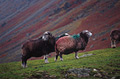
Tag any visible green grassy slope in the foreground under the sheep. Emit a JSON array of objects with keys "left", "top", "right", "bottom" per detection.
[{"left": 0, "top": 47, "right": 120, "bottom": 79}]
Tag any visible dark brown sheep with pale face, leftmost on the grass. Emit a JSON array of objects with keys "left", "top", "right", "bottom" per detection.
[{"left": 22, "top": 31, "right": 55, "bottom": 68}]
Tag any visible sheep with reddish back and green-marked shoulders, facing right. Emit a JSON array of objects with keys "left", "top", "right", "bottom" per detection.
[{"left": 55, "top": 30, "right": 92, "bottom": 61}]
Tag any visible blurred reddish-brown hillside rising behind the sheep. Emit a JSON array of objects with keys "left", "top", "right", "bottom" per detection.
[{"left": 0, "top": 0, "right": 120, "bottom": 63}]
